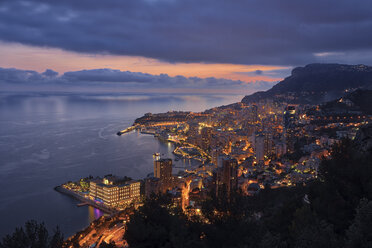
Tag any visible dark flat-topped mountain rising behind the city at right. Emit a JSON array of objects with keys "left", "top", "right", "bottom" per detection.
[{"left": 242, "top": 64, "right": 372, "bottom": 104}]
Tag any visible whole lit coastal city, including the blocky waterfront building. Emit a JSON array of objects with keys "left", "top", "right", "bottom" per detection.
[{"left": 62, "top": 97, "right": 370, "bottom": 213}]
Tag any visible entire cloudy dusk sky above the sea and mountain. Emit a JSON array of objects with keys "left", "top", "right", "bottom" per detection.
[{"left": 0, "top": 0, "right": 372, "bottom": 94}]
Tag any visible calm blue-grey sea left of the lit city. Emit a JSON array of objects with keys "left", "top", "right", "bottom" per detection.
[{"left": 0, "top": 93, "right": 242, "bottom": 237}]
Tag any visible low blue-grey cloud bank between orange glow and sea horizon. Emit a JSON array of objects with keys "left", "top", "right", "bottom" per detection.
[{"left": 0, "top": 68, "right": 275, "bottom": 93}]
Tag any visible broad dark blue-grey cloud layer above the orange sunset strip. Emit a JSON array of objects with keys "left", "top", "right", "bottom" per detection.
[{"left": 0, "top": 0, "right": 372, "bottom": 65}]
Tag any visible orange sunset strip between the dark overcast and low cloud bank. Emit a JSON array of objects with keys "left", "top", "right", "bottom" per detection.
[{"left": 0, "top": 43, "right": 290, "bottom": 82}]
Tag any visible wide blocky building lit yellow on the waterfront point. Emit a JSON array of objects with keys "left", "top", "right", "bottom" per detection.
[{"left": 89, "top": 176, "right": 141, "bottom": 207}]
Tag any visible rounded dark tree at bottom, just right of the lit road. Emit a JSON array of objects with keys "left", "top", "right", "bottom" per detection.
[{"left": 124, "top": 195, "right": 201, "bottom": 247}]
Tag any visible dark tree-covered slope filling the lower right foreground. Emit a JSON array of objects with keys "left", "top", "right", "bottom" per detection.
[{"left": 125, "top": 140, "right": 372, "bottom": 248}]
